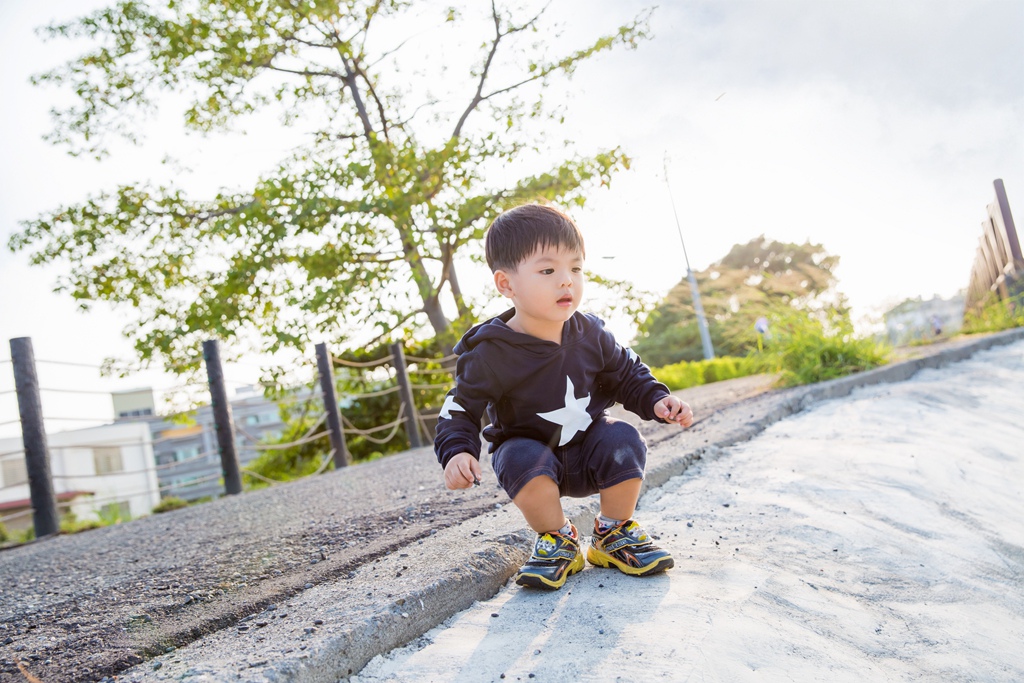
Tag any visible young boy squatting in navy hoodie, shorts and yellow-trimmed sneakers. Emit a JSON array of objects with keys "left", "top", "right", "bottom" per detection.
[{"left": 434, "top": 204, "right": 693, "bottom": 589}]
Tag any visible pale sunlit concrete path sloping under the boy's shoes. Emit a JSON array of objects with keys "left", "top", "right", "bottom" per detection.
[{"left": 351, "top": 341, "right": 1024, "bottom": 683}]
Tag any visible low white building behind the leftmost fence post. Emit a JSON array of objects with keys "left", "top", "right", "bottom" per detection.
[{"left": 0, "top": 422, "right": 160, "bottom": 530}]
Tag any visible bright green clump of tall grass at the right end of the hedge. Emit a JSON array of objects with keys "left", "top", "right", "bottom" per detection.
[{"left": 758, "top": 308, "right": 889, "bottom": 386}]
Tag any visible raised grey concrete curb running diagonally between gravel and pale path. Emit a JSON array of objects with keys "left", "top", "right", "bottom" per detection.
[{"left": 123, "top": 329, "right": 1024, "bottom": 683}]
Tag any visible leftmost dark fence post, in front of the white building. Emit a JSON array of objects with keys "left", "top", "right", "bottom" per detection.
[{"left": 10, "top": 337, "right": 60, "bottom": 539}]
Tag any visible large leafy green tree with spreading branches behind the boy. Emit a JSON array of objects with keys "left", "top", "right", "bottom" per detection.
[{"left": 8, "top": 0, "right": 648, "bottom": 373}]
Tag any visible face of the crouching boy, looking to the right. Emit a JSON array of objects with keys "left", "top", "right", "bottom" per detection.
[{"left": 495, "top": 247, "right": 585, "bottom": 325}]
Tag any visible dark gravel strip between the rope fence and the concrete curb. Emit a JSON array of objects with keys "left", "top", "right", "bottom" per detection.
[{"left": 0, "top": 376, "right": 771, "bottom": 682}]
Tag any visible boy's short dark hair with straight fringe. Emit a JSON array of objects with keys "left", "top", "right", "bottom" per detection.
[{"left": 484, "top": 204, "right": 587, "bottom": 272}]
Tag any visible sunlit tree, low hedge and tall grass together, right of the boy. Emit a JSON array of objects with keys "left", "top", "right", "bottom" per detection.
[{"left": 634, "top": 236, "right": 889, "bottom": 389}]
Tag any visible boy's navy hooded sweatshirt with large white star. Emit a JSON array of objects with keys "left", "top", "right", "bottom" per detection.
[{"left": 434, "top": 308, "right": 669, "bottom": 467}]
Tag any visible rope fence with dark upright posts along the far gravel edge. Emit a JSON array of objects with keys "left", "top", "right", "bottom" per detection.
[{"left": 0, "top": 338, "right": 458, "bottom": 538}]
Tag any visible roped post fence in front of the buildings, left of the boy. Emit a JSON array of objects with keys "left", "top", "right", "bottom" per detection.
[{"left": 0, "top": 340, "right": 457, "bottom": 535}]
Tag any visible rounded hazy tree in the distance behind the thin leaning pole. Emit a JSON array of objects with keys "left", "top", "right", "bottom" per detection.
[{"left": 634, "top": 236, "right": 845, "bottom": 366}]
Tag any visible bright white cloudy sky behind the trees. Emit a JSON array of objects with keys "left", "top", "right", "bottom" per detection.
[{"left": 0, "top": 0, "right": 1024, "bottom": 434}]
